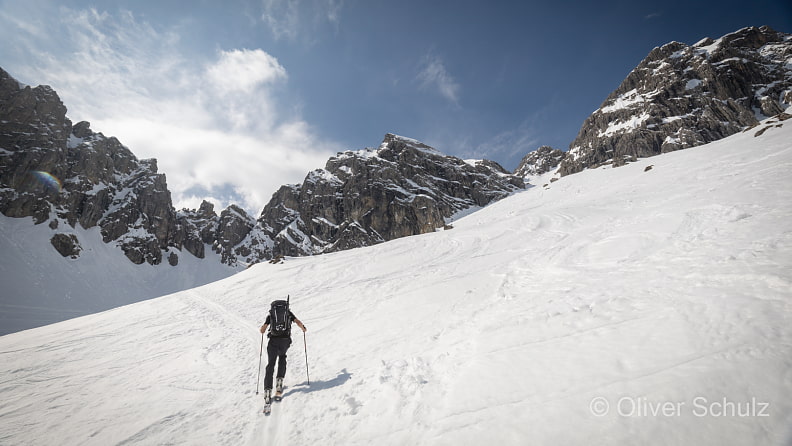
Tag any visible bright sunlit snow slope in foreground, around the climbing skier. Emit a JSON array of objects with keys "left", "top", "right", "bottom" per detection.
[{"left": 0, "top": 116, "right": 792, "bottom": 445}]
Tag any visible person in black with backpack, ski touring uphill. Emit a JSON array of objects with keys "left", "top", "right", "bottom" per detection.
[{"left": 259, "top": 300, "right": 308, "bottom": 405}]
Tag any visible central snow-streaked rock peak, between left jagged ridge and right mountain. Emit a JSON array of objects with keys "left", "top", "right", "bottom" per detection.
[{"left": 251, "top": 134, "right": 525, "bottom": 258}]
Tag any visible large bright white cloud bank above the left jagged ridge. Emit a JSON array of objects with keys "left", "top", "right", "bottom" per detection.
[{"left": 0, "top": 8, "right": 339, "bottom": 215}]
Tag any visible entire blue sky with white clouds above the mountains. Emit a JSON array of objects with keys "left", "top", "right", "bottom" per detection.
[{"left": 0, "top": 0, "right": 792, "bottom": 215}]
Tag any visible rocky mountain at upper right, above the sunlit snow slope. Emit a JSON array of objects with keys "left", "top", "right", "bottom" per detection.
[{"left": 559, "top": 26, "right": 792, "bottom": 175}]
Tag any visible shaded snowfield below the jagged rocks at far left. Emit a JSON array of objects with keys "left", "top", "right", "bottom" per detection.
[{"left": 0, "top": 220, "right": 239, "bottom": 335}]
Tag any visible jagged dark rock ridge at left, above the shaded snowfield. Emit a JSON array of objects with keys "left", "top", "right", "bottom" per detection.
[{"left": 0, "top": 69, "right": 253, "bottom": 265}]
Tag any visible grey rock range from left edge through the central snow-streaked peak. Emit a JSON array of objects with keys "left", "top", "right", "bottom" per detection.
[{"left": 0, "top": 69, "right": 524, "bottom": 272}]
